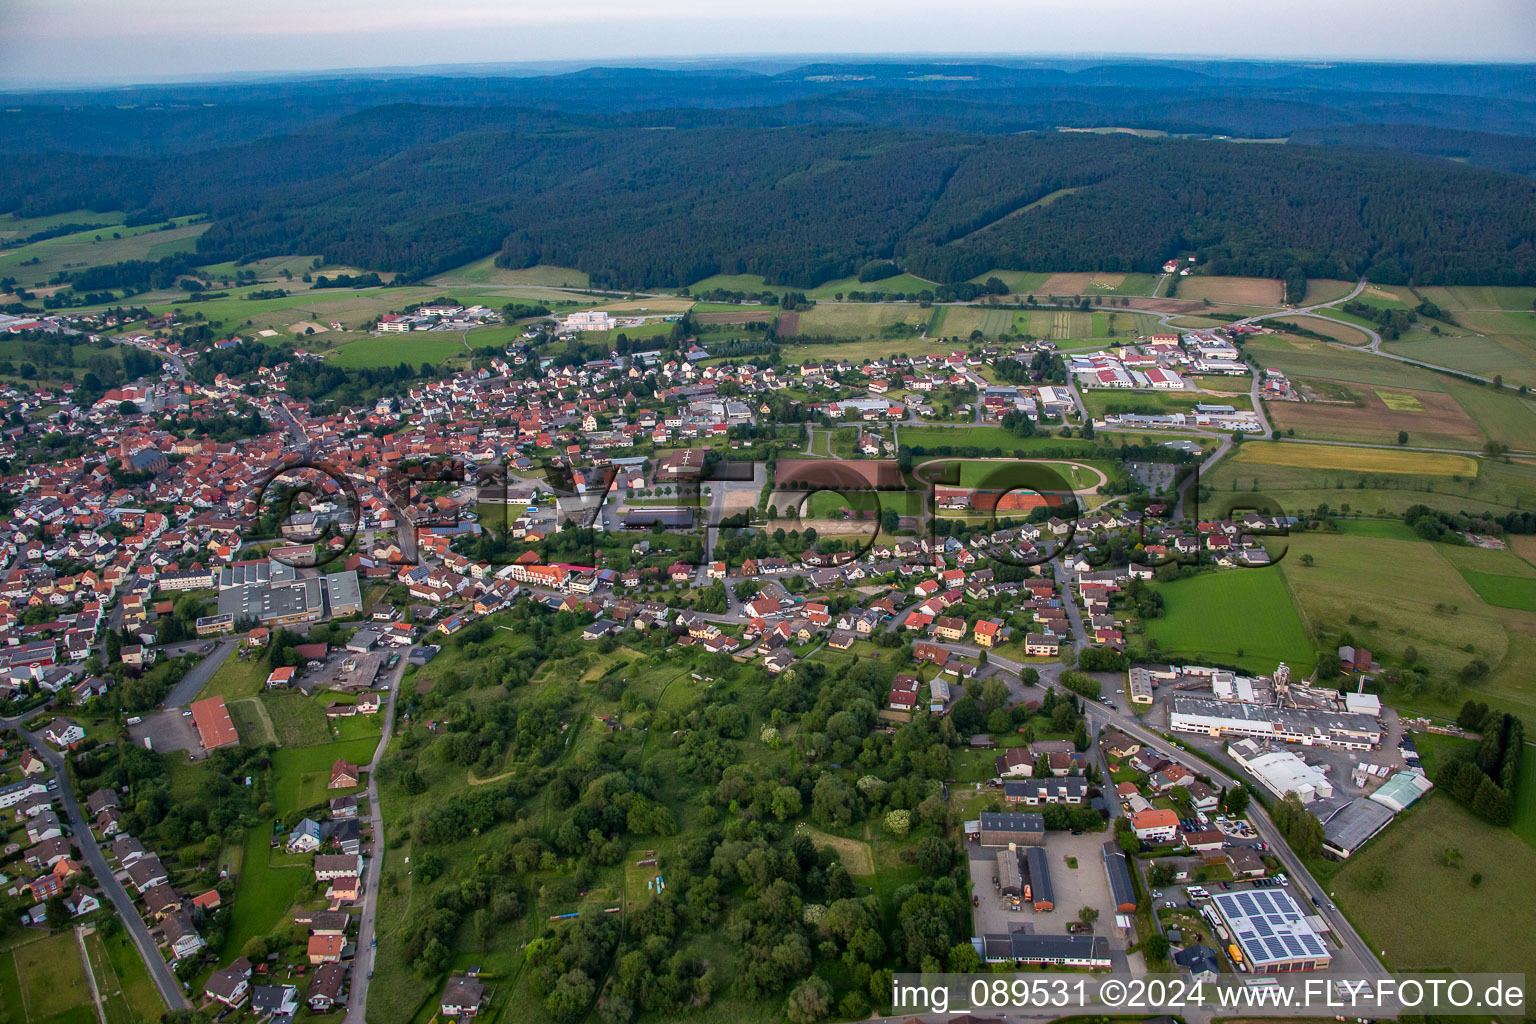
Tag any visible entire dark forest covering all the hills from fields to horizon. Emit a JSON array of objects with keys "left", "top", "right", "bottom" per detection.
[{"left": 9, "top": 64, "right": 1536, "bottom": 289}]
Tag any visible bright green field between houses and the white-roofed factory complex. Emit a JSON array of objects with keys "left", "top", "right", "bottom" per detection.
[{"left": 1141, "top": 574, "right": 1316, "bottom": 676}]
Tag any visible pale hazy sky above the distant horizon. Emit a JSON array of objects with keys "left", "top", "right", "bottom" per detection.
[{"left": 0, "top": 0, "right": 1536, "bottom": 83}]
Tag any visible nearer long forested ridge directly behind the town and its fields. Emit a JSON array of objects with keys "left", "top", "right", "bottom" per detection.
[{"left": 12, "top": 116, "right": 1536, "bottom": 287}]
